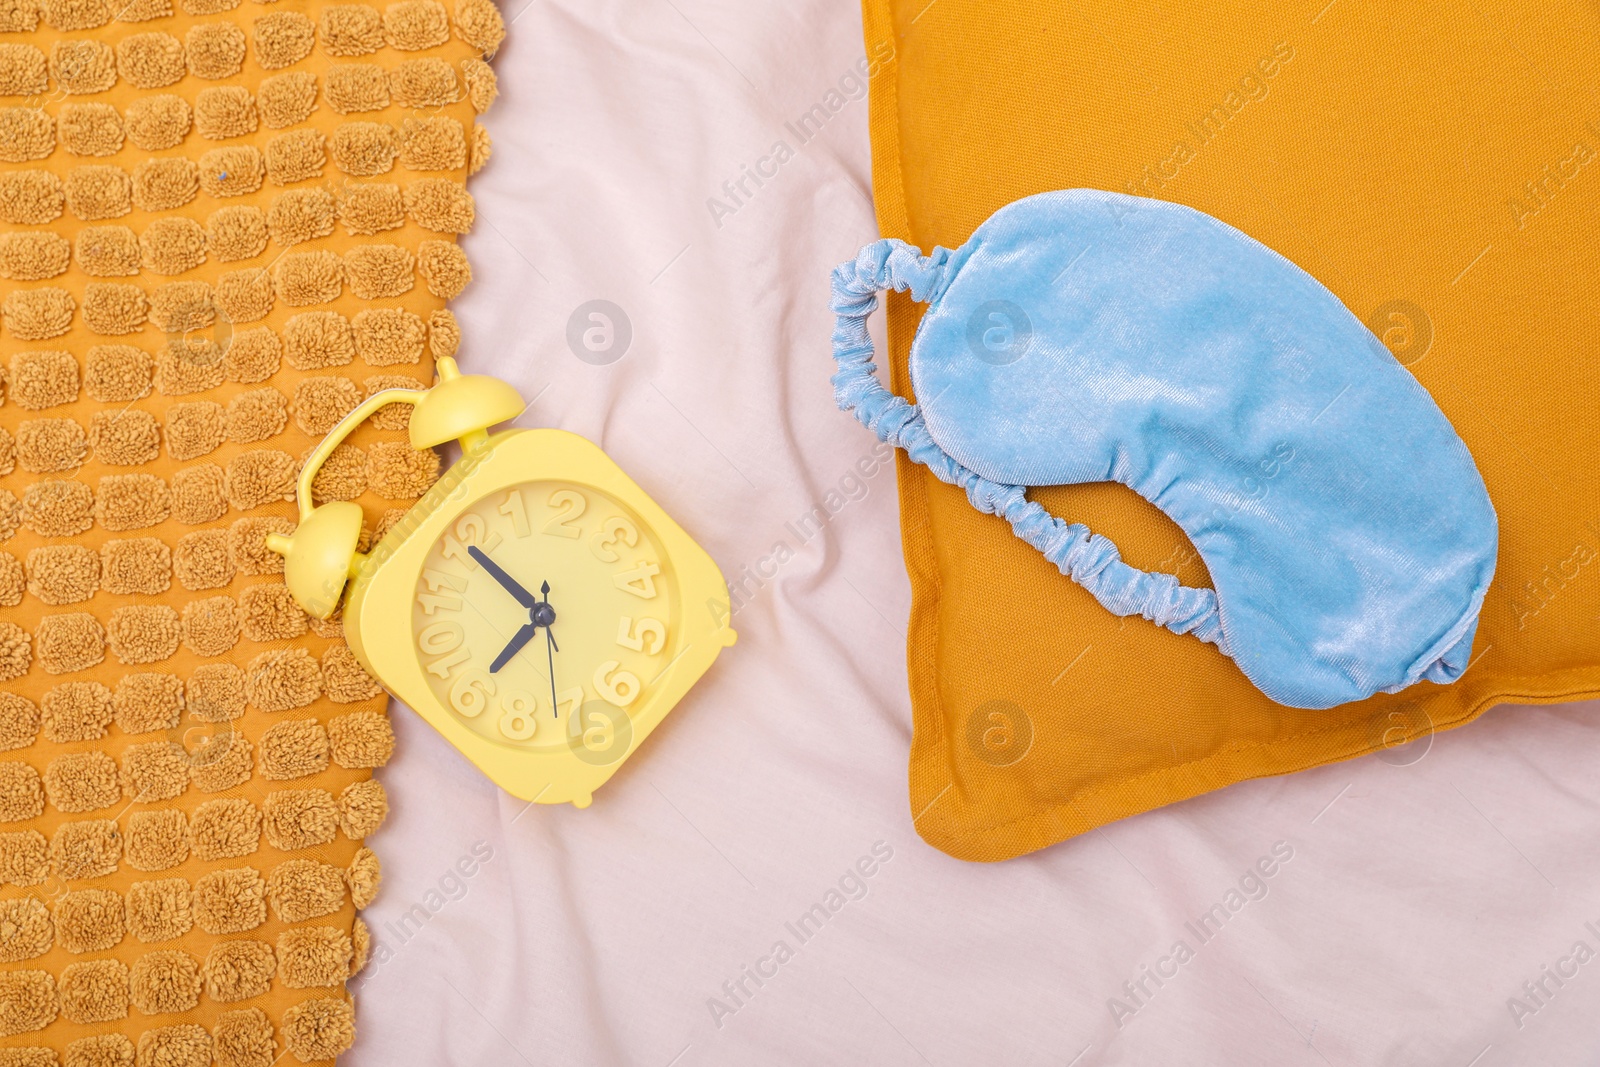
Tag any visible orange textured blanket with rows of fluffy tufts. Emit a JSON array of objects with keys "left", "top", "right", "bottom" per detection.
[{"left": 0, "top": 0, "right": 504, "bottom": 1067}]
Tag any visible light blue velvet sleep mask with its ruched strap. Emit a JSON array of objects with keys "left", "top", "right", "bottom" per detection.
[{"left": 832, "top": 189, "right": 1499, "bottom": 709}]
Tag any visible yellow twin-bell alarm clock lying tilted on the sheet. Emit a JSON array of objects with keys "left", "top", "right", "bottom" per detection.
[{"left": 267, "top": 358, "right": 734, "bottom": 808}]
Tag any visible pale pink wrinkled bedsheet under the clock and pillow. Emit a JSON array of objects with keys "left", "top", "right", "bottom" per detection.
[{"left": 346, "top": 0, "right": 1600, "bottom": 1067}]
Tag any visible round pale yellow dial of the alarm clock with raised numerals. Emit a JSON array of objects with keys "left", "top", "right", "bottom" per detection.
[{"left": 411, "top": 482, "right": 682, "bottom": 765}]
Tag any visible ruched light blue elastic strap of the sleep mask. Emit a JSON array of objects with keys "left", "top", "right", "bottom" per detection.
[{"left": 830, "top": 238, "right": 1232, "bottom": 654}]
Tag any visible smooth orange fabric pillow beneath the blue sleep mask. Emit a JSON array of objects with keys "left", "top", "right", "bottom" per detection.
[{"left": 864, "top": 0, "right": 1600, "bottom": 861}]
